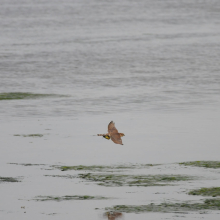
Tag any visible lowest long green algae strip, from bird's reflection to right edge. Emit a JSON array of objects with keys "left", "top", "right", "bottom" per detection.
[{"left": 105, "top": 199, "right": 220, "bottom": 213}]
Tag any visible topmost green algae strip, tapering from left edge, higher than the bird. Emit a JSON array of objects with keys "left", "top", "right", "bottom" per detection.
[{"left": 0, "top": 92, "right": 67, "bottom": 100}]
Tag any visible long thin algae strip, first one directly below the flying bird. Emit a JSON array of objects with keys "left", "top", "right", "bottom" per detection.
[{"left": 53, "top": 164, "right": 159, "bottom": 171}]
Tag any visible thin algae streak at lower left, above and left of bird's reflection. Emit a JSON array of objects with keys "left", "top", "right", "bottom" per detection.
[{"left": 34, "top": 195, "right": 108, "bottom": 202}]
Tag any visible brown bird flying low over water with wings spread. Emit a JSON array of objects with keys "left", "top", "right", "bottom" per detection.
[{"left": 97, "top": 121, "right": 125, "bottom": 145}]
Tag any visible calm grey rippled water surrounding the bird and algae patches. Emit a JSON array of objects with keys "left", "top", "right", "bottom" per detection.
[{"left": 0, "top": 0, "right": 220, "bottom": 220}]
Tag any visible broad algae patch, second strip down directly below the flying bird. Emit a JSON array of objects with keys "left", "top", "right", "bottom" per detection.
[{"left": 78, "top": 173, "right": 195, "bottom": 187}]
